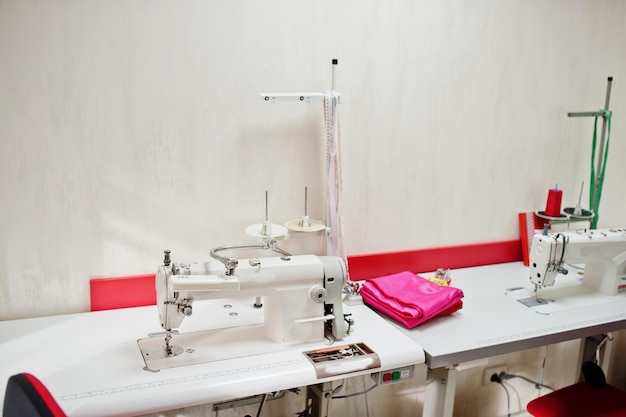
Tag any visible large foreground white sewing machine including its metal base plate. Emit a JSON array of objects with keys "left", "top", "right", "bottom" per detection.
[{"left": 138, "top": 241, "right": 350, "bottom": 370}]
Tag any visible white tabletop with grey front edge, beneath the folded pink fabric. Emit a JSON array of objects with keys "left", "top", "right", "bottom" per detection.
[{"left": 394, "top": 262, "right": 626, "bottom": 369}]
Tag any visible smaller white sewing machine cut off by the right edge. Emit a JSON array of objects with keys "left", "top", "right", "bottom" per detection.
[{"left": 529, "top": 228, "right": 626, "bottom": 295}]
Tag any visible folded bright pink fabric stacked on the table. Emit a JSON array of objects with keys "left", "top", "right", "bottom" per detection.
[{"left": 360, "top": 271, "right": 463, "bottom": 329}]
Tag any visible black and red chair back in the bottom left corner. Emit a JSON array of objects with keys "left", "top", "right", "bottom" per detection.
[{"left": 2, "top": 373, "right": 66, "bottom": 417}]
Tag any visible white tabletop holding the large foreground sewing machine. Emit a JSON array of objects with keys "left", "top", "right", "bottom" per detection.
[{"left": 0, "top": 300, "right": 424, "bottom": 416}]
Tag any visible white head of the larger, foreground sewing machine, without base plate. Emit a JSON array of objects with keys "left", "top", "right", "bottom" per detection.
[{"left": 156, "top": 241, "right": 349, "bottom": 355}]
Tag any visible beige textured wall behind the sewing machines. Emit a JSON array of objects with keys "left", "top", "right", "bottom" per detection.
[{"left": 0, "top": 0, "right": 626, "bottom": 415}]
